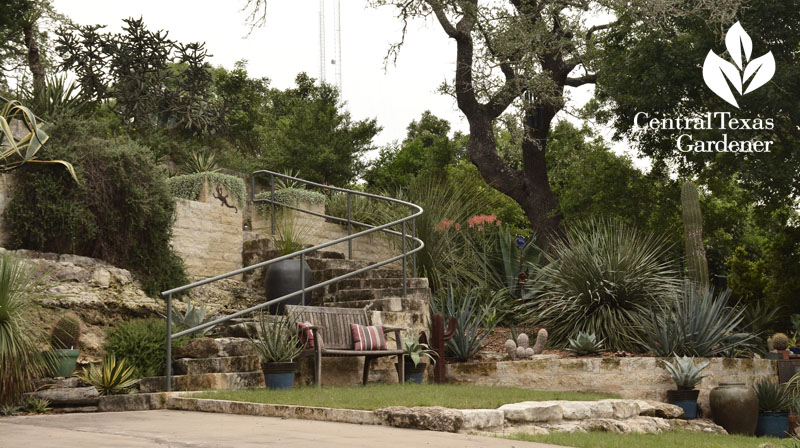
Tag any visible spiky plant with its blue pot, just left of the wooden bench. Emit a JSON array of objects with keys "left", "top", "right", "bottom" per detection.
[{"left": 251, "top": 314, "right": 303, "bottom": 389}]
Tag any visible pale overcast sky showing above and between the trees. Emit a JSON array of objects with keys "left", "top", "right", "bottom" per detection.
[{"left": 53, "top": 0, "right": 640, "bottom": 165}]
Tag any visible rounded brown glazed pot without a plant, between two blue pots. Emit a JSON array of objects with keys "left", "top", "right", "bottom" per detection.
[{"left": 709, "top": 383, "right": 758, "bottom": 436}]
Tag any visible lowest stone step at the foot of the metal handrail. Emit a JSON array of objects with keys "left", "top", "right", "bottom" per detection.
[{"left": 139, "top": 372, "right": 265, "bottom": 393}]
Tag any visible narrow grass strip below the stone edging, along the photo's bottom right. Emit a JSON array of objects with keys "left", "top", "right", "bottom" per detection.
[{"left": 508, "top": 431, "right": 784, "bottom": 448}]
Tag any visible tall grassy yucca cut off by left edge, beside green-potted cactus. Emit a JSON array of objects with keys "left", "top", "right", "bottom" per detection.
[{"left": 0, "top": 254, "right": 54, "bottom": 405}]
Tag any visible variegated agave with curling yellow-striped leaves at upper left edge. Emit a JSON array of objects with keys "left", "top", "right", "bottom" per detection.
[{"left": 0, "top": 101, "right": 78, "bottom": 182}]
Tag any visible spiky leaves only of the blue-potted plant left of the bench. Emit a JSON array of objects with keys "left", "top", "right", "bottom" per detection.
[{"left": 251, "top": 314, "right": 303, "bottom": 362}]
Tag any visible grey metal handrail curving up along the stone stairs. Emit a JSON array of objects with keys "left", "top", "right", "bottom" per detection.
[{"left": 161, "top": 170, "right": 425, "bottom": 392}]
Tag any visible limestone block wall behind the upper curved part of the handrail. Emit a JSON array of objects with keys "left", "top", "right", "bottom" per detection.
[{"left": 248, "top": 198, "right": 400, "bottom": 262}]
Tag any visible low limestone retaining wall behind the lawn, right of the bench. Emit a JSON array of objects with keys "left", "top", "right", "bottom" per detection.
[{"left": 447, "top": 355, "right": 778, "bottom": 415}]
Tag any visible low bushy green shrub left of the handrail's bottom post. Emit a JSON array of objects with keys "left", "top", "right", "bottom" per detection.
[{"left": 106, "top": 319, "right": 189, "bottom": 378}]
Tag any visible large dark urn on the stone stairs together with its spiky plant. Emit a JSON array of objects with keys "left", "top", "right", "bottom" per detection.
[{"left": 266, "top": 209, "right": 313, "bottom": 314}]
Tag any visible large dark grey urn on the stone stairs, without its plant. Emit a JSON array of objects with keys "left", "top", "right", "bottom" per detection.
[{"left": 266, "top": 259, "right": 314, "bottom": 314}]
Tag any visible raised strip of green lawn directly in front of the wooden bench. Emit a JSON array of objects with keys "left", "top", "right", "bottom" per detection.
[{"left": 193, "top": 384, "right": 619, "bottom": 411}]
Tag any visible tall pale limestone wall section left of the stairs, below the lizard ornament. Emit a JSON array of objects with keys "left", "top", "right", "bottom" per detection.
[{"left": 172, "top": 197, "right": 243, "bottom": 279}]
